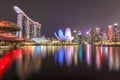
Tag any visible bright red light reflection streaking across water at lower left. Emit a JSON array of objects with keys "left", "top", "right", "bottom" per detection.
[{"left": 0, "top": 49, "right": 22, "bottom": 79}]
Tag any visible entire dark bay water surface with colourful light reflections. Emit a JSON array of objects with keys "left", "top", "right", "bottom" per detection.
[{"left": 0, "top": 44, "right": 120, "bottom": 80}]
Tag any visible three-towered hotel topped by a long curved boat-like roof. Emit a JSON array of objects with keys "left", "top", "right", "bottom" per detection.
[{"left": 13, "top": 6, "right": 41, "bottom": 39}]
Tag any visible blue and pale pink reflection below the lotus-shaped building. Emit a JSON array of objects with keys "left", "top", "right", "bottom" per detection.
[{"left": 55, "top": 46, "right": 74, "bottom": 66}]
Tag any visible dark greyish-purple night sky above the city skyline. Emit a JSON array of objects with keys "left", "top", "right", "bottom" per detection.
[{"left": 0, "top": 0, "right": 120, "bottom": 37}]
